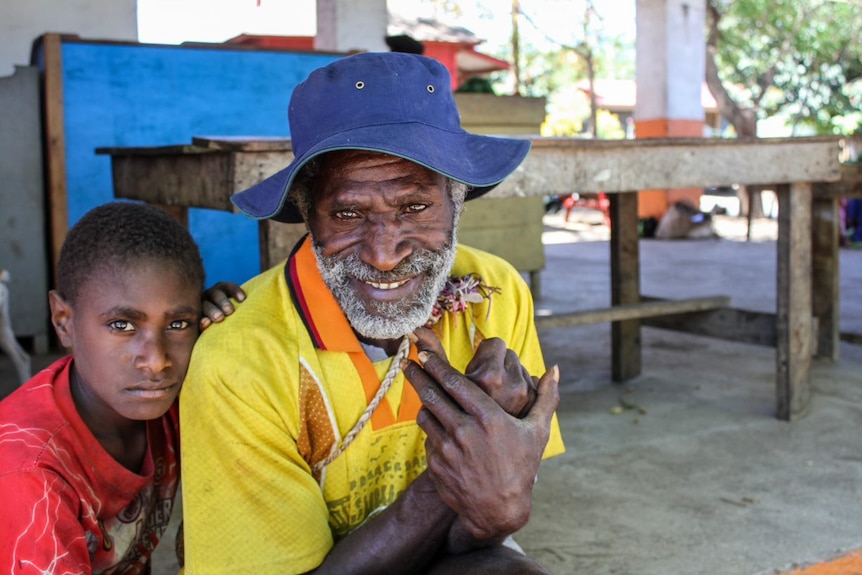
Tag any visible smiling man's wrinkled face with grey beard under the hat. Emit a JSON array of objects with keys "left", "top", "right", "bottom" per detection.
[{"left": 308, "top": 150, "right": 455, "bottom": 339}]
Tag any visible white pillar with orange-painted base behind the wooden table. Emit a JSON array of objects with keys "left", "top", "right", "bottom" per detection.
[{"left": 634, "top": 0, "right": 706, "bottom": 219}]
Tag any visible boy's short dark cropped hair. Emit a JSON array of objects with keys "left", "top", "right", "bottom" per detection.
[{"left": 57, "top": 201, "right": 205, "bottom": 304}]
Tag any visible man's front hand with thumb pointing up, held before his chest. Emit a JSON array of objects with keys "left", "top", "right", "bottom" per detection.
[{"left": 404, "top": 338, "right": 559, "bottom": 540}]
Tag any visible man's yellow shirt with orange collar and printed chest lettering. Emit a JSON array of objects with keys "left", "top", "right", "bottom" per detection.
[{"left": 180, "top": 236, "right": 564, "bottom": 575}]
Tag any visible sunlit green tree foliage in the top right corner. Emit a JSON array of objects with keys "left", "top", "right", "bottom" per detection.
[{"left": 710, "top": 0, "right": 862, "bottom": 134}]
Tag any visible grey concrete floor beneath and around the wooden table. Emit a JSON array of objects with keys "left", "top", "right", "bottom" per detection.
[{"left": 0, "top": 214, "right": 862, "bottom": 575}]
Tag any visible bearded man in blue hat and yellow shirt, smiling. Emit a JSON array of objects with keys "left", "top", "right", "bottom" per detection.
[{"left": 181, "top": 53, "right": 563, "bottom": 574}]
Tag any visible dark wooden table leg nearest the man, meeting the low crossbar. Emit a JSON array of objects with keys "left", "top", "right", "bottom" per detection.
[{"left": 608, "top": 192, "right": 641, "bottom": 382}]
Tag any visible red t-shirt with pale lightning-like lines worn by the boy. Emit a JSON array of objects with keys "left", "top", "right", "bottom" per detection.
[{"left": 0, "top": 356, "right": 180, "bottom": 574}]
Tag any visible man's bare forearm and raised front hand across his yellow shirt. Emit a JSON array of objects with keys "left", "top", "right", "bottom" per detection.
[{"left": 313, "top": 360, "right": 559, "bottom": 574}]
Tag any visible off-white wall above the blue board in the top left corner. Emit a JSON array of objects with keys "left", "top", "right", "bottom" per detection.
[{"left": 0, "top": 0, "right": 138, "bottom": 76}]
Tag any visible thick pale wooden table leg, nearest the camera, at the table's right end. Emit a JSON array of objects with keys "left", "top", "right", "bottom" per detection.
[{"left": 775, "top": 183, "right": 813, "bottom": 421}]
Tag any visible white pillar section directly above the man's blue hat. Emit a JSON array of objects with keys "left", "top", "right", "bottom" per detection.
[{"left": 314, "top": 0, "right": 389, "bottom": 52}]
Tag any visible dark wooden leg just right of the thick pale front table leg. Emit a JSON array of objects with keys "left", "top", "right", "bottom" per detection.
[{"left": 811, "top": 198, "right": 841, "bottom": 361}]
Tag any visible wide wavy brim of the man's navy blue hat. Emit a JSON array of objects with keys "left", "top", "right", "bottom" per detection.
[{"left": 231, "top": 123, "right": 531, "bottom": 223}]
